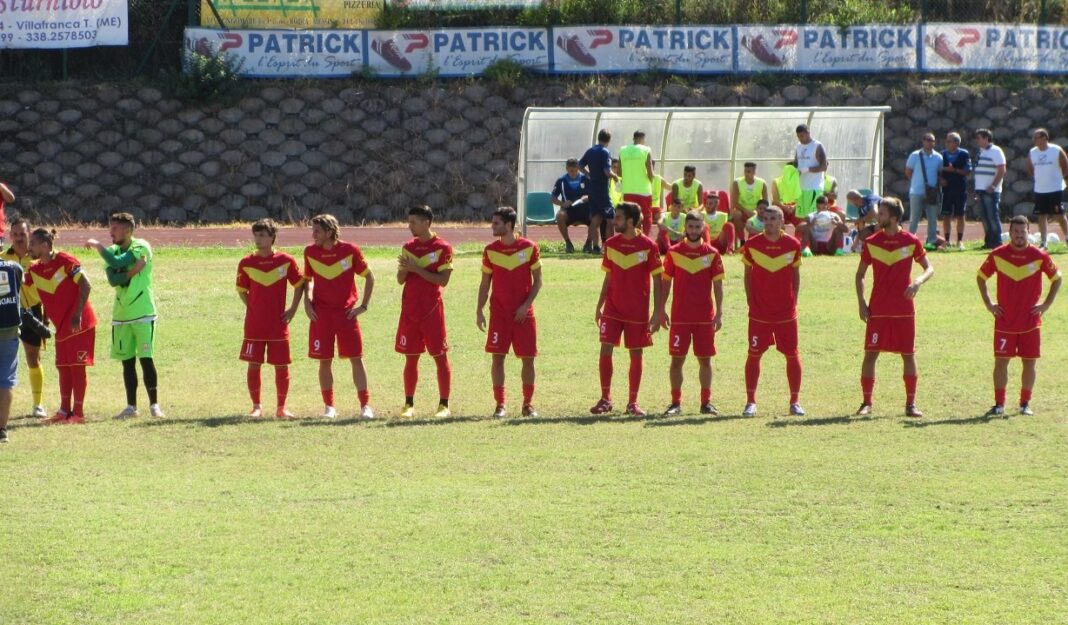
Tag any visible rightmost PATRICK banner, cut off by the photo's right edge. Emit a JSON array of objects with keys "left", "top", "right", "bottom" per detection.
[{"left": 921, "top": 24, "right": 1068, "bottom": 74}]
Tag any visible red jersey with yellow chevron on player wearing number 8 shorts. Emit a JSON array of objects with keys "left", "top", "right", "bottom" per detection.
[{"left": 861, "top": 230, "right": 927, "bottom": 317}]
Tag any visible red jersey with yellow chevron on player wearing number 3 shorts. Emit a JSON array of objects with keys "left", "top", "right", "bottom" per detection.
[{"left": 482, "top": 237, "right": 541, "bottom": 318}]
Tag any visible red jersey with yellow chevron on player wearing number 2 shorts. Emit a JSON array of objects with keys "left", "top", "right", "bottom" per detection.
[{"left": 664, "top": 240, "right": 723, "bottom": 324}]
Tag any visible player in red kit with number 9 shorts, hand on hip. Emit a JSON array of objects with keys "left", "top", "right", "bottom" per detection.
[{"left": 304, "top": 215, "right": 375, "bottom": 420}]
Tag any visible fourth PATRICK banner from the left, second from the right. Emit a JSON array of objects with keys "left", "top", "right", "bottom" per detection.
[{"left": 736, "top": 26, "right": 918, "bottom": 74}]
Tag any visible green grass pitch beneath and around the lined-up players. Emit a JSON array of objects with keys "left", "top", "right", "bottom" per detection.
[{"left": 0, "top": 241, "right": 1068, "bottom": 625}]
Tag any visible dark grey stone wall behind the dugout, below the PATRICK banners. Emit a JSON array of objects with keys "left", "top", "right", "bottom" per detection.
[{"left": 0, "top": 78, "right": 1068, "bottom": 224}]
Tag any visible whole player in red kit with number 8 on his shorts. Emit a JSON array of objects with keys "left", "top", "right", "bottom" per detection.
[{"left": 855, "top": 198, "right": 935, "bottom": 418}]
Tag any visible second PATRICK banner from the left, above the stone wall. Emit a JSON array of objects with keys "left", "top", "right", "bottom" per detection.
[{"left": 367, "top": 28, "right": 550, "bottom": 77}]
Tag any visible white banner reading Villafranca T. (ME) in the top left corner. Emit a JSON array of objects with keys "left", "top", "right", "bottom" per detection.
[{"left": 0, "top": 0, "right": 129, "bottom": 48}]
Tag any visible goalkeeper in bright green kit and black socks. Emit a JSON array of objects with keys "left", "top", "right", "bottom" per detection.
[{"left": 85, "top": 213, "right": 164, "bottom": 419}]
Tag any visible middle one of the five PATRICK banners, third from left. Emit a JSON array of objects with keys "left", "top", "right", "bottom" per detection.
[{"left": 552, "top": 26, "right": 735, "bottom": 74}]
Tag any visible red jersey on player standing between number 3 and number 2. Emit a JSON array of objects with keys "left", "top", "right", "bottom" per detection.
[{"left": 601, "top": 234, "right": 664, "bottom": 324}]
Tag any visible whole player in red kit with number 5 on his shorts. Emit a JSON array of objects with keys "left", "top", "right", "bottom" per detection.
[{"left": 741, "top": 206, "right": 804, "bottom": 417}]
